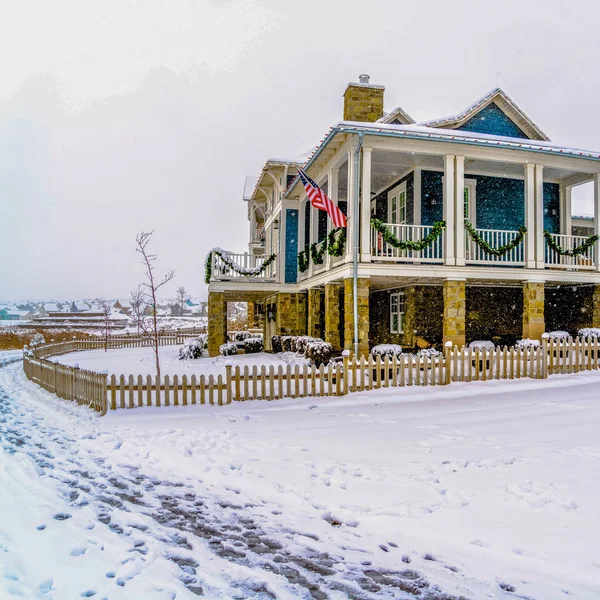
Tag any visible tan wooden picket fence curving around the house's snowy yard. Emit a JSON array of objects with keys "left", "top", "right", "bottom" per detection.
[{"left": 23, "top": 334, "right": 600, "bottom": 414}]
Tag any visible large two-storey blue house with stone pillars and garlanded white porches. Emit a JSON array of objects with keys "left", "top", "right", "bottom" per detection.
[{"left": 207, "top": 76, "right": 600, "bottom": 354}]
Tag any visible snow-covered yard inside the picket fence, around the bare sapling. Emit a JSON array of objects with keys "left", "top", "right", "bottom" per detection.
[{"left": 52, "top": 346, "right": 310, "bottom": 376}]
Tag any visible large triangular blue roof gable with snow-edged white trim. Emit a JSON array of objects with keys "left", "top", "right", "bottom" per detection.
[{"left": 421, "top": 88, "right": 549, "bottom": 141}]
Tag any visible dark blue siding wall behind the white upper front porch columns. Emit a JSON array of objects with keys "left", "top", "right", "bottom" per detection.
[{"left": 421, "top": 171, "right": 560, "bottom": 233}]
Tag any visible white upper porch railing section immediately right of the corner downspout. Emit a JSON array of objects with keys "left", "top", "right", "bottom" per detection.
[{"left": 371, "top": 223, "right": 444, "bottom": 263}]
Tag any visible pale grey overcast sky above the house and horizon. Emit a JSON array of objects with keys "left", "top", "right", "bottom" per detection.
[{"left": 0, "top": 0, "right": 600, "bottom": 300}]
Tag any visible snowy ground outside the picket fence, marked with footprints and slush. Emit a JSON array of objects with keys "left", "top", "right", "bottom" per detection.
[{"left": 0, "top": 353, "right": 600, "bottom": 600}]
